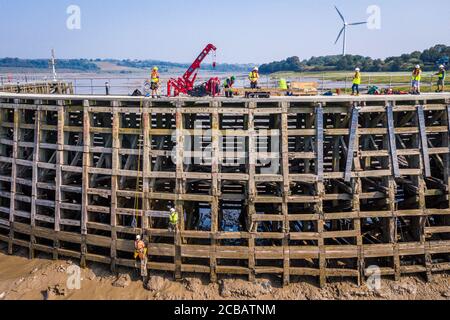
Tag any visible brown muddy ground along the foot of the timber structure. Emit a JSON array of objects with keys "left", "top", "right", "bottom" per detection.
[{"left": 0, "top": 244, "right": 450, "bottom": 300}]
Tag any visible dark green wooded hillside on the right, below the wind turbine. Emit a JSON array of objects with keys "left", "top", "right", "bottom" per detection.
[{"left": 260, "top": 45, "right": 450, "bottom": 74}]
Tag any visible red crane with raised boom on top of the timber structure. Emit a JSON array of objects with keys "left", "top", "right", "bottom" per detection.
[{"left": 167, "top": 44, "right": 220, "bottom": 97}]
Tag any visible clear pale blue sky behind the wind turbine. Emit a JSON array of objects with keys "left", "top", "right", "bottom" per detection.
[{"left": 0, "top": 0, "right": 450, "bottom": 63}]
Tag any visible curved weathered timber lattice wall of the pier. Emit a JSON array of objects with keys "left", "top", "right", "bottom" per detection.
[{"left": 0, "top": 93, "right": 450, "bottom": 285}]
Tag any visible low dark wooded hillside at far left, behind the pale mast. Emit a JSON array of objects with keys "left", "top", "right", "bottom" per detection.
[{"left": 0, "top": 58, "right": 100, "bottom": 71}]
